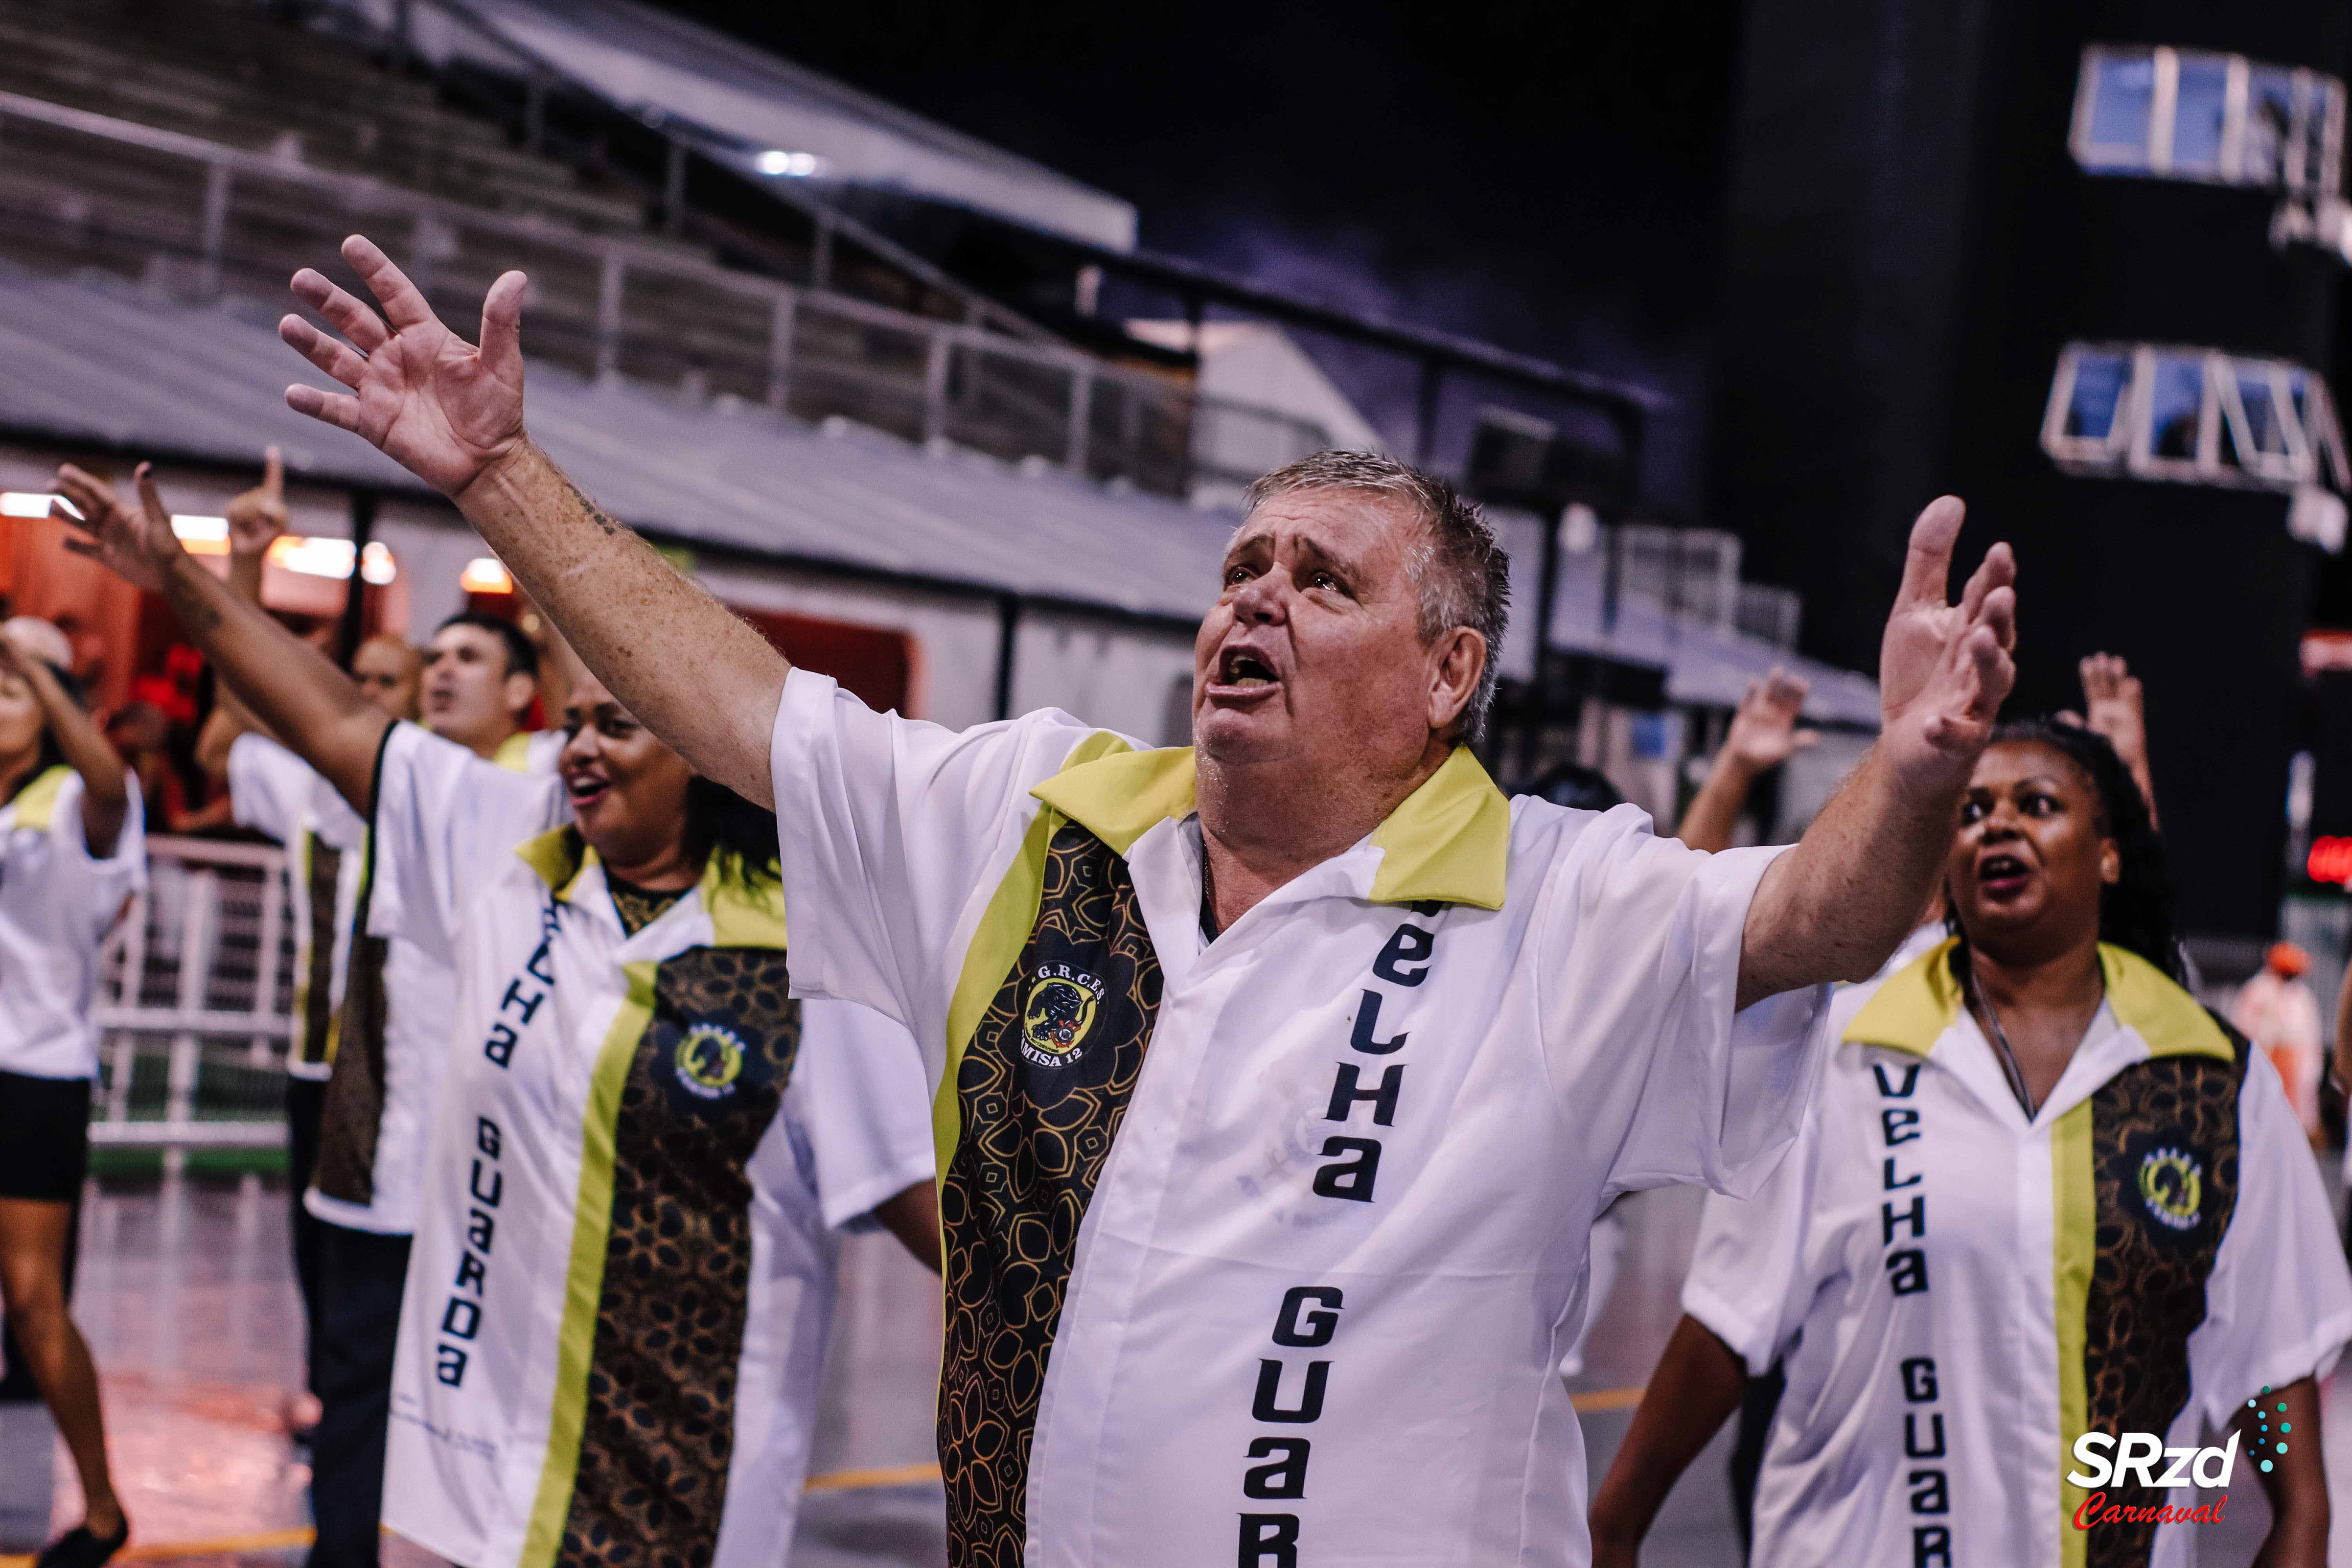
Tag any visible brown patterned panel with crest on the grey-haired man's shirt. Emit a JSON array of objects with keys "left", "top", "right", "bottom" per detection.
[{"left": 938, "top": 823, "right": 1160, "bottom": 1568}]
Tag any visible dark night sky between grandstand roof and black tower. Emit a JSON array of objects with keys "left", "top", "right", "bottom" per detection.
[{"left": 644, "top": 0, "right": 1738, "bottom": 515}]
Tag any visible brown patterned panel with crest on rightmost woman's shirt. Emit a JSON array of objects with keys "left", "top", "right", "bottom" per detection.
[{"left": 2082, "top": 1025, "right": 2251, "bottom": 1568}]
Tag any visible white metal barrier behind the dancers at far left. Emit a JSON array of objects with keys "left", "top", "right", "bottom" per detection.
[{"left": 89, "top": 837, "right": 294, "bottom": 1150}]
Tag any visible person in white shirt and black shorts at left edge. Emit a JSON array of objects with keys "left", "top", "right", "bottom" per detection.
[{"left": 0, "top": 618, "right": 146, "bottom": 1568}]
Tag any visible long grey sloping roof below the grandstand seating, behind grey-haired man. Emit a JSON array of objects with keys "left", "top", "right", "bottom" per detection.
[{"left": 0, "top": 266, "right": 1879, "bottom": 729}]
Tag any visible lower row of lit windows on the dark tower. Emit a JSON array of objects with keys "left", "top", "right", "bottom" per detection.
[{"left": 2042, "top": 343, "right": 2352, "bottom": 491}]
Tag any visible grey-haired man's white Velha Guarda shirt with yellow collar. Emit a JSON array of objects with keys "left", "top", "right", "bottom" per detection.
[{"left": 774, "top": 670, "right": 1825, "bottom": 1568}]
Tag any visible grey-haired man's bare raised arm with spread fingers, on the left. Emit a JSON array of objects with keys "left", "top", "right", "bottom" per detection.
[{"left": 278, "top": 235, "right": 790, "bottom": 822}]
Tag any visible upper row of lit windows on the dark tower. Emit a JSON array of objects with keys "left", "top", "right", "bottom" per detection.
[{"left": 2070, "top": 45, "right": 2345, "bottom": 198}]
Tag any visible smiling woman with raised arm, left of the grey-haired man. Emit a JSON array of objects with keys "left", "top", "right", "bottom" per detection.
[{"left": 59, "top": 468, "right": 938, "bottom": 1568}]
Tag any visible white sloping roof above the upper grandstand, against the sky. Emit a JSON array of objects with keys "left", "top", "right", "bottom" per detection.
[{"left": 336, "top": 0, "right": 1136, "bottom": 249}]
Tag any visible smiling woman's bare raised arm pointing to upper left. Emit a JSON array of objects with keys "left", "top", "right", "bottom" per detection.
[{"left": 49, "top": 463, "right": 390, "bottom": 816}]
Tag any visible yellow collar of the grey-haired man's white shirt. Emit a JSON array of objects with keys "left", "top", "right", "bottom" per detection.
[{"left": 1030, "top": 731, "right": 1510, "bottom": 910}]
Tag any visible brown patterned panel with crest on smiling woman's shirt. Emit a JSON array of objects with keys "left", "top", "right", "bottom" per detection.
[{"left": 557, "top": 947, "right": 800, "bottom": 1568}]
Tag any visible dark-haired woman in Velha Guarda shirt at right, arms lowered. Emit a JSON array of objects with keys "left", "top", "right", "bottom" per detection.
[{"left": 1592, "top": 719, "right": 2352, "bottom": 1568}]
